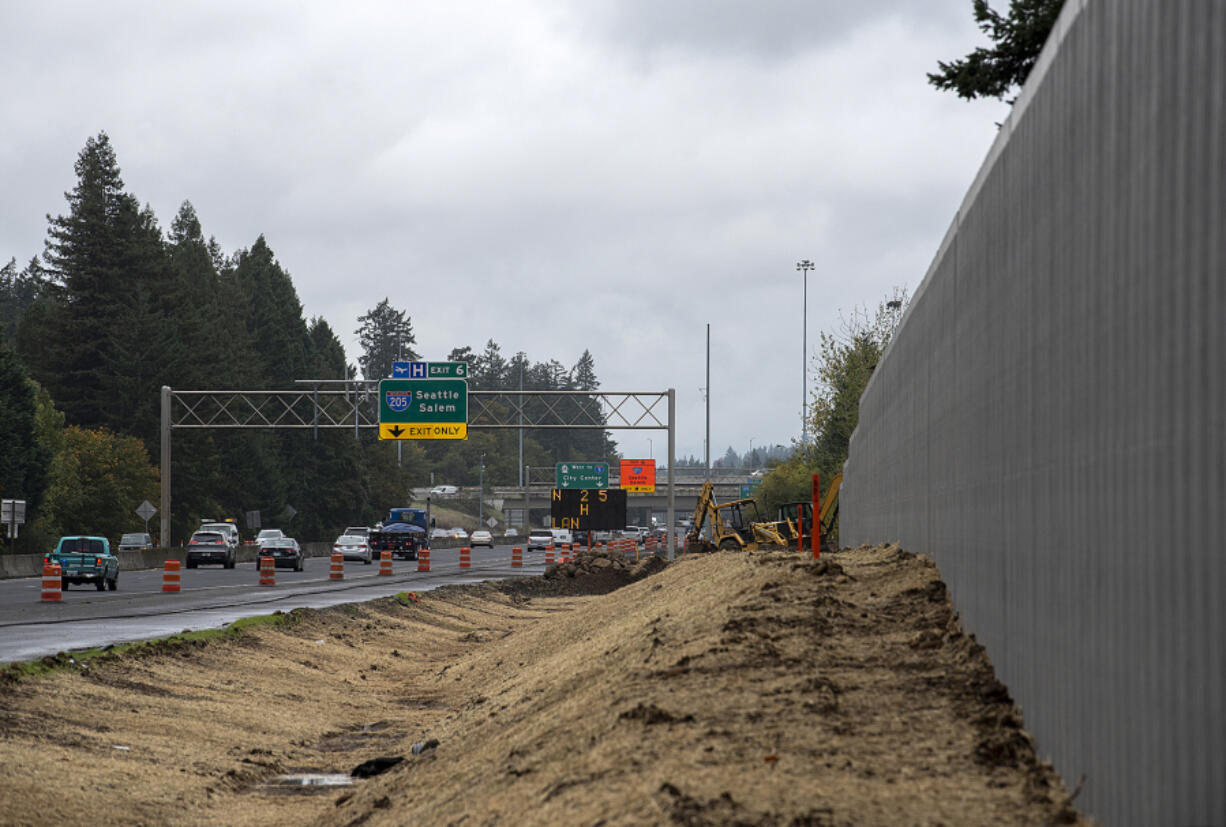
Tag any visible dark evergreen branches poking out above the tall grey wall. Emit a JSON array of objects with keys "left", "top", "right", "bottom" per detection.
[{"left": 928, "top": 0, "right": 1064, "bottom": 103}]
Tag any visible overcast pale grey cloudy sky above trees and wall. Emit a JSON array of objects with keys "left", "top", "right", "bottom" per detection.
[{"left": 0, "top": 0, "right": 1007, "bottom": 461}]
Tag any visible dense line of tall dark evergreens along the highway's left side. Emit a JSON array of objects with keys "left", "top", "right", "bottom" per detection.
[{"left": 0, "top": 132, "right": 615, "bottom": 550}]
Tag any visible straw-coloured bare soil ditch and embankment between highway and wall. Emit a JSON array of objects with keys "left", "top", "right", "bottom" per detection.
[{"left": 0, "top": 546, "right": 1083, "bottom": 826}]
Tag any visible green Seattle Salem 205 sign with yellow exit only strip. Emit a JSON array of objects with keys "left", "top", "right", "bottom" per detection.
[{"left": 379, "top": 377, "right": 468, "bottom": 440}]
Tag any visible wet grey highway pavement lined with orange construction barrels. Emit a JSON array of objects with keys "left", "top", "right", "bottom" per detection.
[{"left": 0, "top": 545, "right": 544, "bottom": 664}]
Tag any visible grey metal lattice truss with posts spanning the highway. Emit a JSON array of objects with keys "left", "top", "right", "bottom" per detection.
[{"left": 161, "top": 380, "right": 677, "bottom": 555}]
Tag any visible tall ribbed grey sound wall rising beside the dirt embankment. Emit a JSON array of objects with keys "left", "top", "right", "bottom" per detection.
[{"left": 841, "top": 0, "right": 1226, "bottom": 825}]
